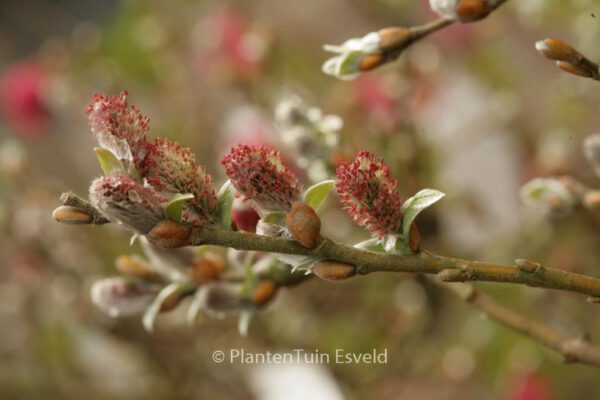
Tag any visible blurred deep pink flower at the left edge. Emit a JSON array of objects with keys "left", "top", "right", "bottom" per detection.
[{"left": 0, "top": 61, "right": 51, "bottom": 138}]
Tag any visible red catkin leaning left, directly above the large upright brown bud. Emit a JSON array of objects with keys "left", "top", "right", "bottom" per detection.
[{"left": 221, "top": 144, "right": 302, "bottom": 211}]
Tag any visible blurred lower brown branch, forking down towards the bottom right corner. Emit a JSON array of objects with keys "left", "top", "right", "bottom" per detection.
[{"left": 437, "top": 282, "right": 600, "bottom": 367}]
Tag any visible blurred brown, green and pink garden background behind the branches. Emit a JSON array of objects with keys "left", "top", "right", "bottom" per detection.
[{"left": 0, "top": 0, "right": 600, "bottom": 400}]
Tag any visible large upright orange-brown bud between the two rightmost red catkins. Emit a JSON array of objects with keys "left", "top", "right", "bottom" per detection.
[{"left": 285, "top": 201, "right": 323, "bottom": 249}]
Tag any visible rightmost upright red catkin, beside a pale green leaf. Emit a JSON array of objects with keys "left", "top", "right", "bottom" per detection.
[{"left": 336, "top": 151, "right": 402, "bottom": 238}]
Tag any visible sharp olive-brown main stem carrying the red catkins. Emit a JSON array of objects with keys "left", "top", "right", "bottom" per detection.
[{"left": 190, "top": 229, "right": 600, "bottom": 297}]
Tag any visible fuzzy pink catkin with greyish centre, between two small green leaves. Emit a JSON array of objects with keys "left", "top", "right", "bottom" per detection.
[{"left": 143, "top": 139, "right": 217, "bottom": 226}]
